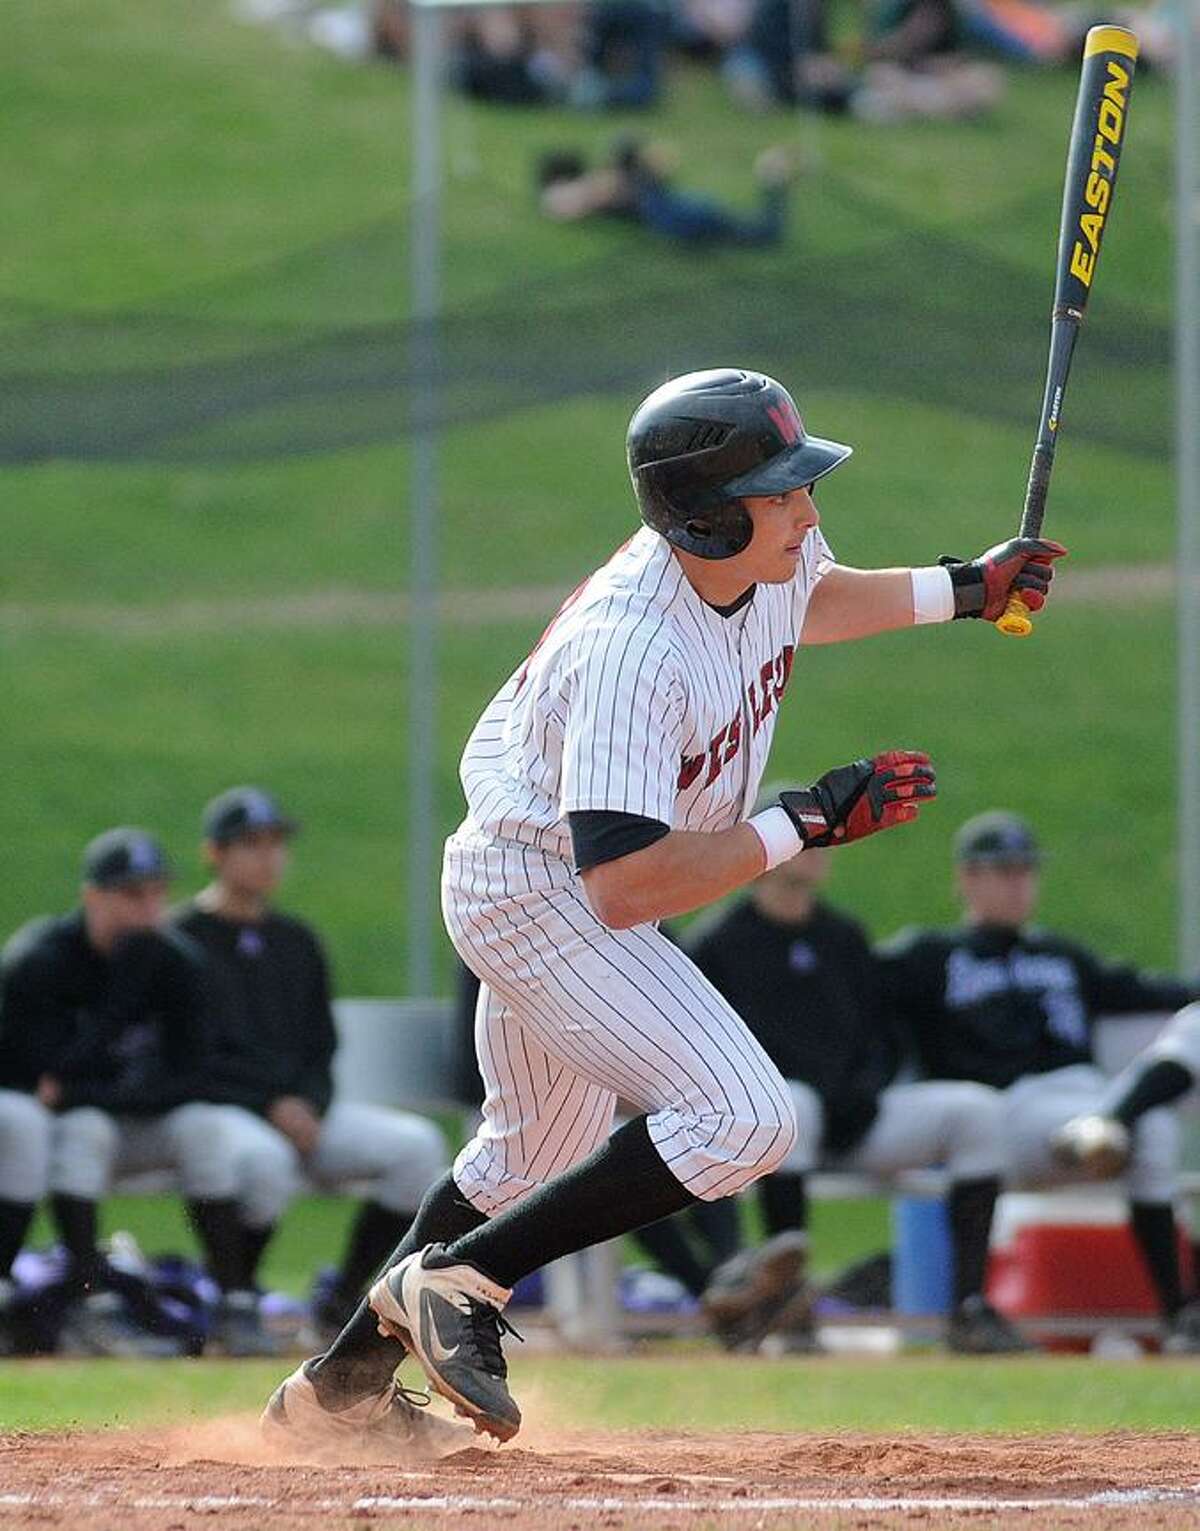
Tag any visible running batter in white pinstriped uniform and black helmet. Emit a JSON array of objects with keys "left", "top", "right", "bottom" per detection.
[{"left": 266, "top": 367, "right": 1064, "bottom": 1442}]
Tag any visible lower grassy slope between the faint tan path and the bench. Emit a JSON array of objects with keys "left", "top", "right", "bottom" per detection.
[{"left": 0, "top": 606, "right": 1174, "bottom": 992}]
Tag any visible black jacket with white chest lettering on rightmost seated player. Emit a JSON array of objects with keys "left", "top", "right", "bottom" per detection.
[{"left": 879, "top": 925, "right": 1200, "bottom": 1090}]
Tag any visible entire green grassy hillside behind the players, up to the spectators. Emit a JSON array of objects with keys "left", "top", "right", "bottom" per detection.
[{"left": 0, "top": 0, "right": 1174, "bottom": 992}]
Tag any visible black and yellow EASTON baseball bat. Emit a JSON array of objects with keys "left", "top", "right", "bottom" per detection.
[{"left": 996, "top": 26, "right": 1137, "bottom": 638}]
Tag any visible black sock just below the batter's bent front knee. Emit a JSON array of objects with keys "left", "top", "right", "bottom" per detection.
[{"left": 447, "top": 1116, "right": 696, "bottom": 1286}]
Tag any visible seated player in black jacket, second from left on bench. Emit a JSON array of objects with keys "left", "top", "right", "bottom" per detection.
[{"left": 173, "top": 787, "right": 447, "bottom": 1334}]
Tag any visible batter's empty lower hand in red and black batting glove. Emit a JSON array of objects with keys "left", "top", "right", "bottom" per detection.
[{"left": 779, "top": 750, "right": 937, "bottom": 850}]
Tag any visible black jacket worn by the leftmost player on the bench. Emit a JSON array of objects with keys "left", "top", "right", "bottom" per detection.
[{"left": 0, "top": 911, "right": 207, "bottom": 1116}]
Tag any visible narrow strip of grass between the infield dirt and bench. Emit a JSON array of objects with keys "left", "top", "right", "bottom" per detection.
[{"left": 0, "top": 1341, "right": 1195, "bottom": 1433}]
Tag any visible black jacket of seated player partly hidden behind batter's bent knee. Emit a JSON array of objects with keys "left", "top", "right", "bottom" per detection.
[{"left": 687, "top": 899, "right": 897, "bottom": 1153}]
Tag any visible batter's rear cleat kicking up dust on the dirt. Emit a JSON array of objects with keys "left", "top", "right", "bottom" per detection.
[{"left": 259, "top": 1361, "right": 474, "bottom": 1467}]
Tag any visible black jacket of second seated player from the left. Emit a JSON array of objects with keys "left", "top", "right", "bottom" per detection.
[{"left": 173, "top": 903, "right": 337, "bottom": 1115}]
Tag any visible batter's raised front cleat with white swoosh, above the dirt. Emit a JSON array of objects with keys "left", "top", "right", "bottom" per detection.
[{"left": 367, "top": 1245, "right": 520, "bottom": 1441}]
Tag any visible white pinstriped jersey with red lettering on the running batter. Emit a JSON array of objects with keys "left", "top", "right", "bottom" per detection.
[{"left": 458, "top": 528, "right": 833, "bottom": 882}]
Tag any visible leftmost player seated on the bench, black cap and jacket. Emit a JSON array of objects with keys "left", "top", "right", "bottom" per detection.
[{"left": 0, "top": 828, "right": 274, "bottom": 1355}]
